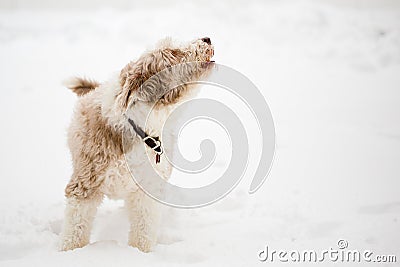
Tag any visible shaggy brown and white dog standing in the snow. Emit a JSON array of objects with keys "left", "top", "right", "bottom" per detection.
[{"left": 61, "top": 38, "right": 214, "bottom": 252}]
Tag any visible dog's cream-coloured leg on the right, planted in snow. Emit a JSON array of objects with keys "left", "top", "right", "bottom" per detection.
[{"left": 125, "top": 190, "right": 160, "bottom": 252}]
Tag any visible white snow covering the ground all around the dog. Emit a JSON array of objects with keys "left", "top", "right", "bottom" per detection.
[{"left": 0, "top": 0, "right": 400, "bottom": 266}]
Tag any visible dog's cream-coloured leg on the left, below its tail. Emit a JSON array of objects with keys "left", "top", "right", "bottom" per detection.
[{"left": 61, "top": 195, "right": 103, "bottom": 251}]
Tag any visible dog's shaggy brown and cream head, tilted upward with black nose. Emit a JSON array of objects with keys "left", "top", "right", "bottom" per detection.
[{"left": 117, "top": 37, "right": 214, "bottom": 108}]
